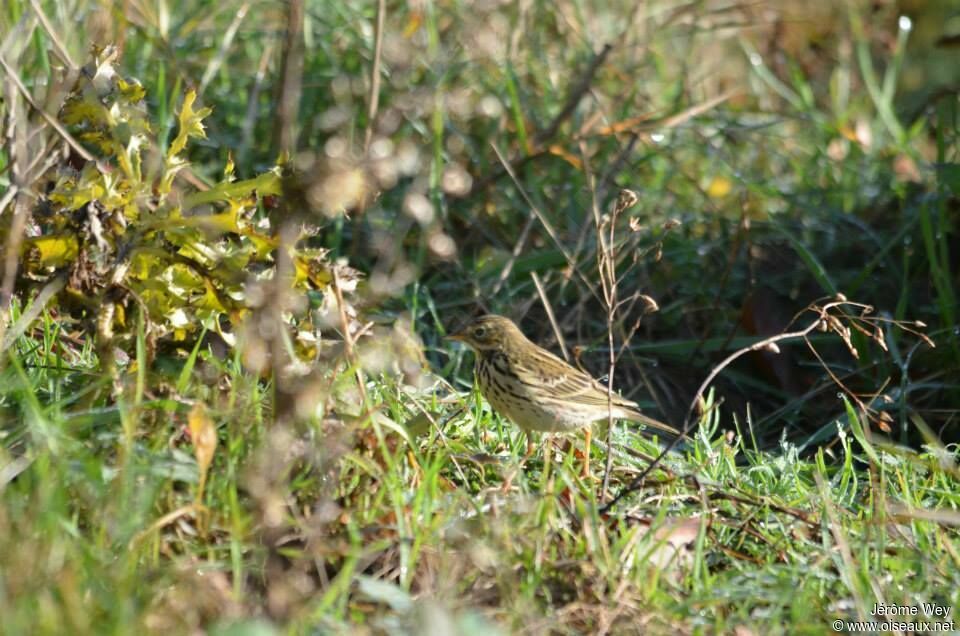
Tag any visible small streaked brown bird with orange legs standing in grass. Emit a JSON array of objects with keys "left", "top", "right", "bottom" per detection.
[{"left": 449, "top": 315, "right": 680, "bottom": 476}]
